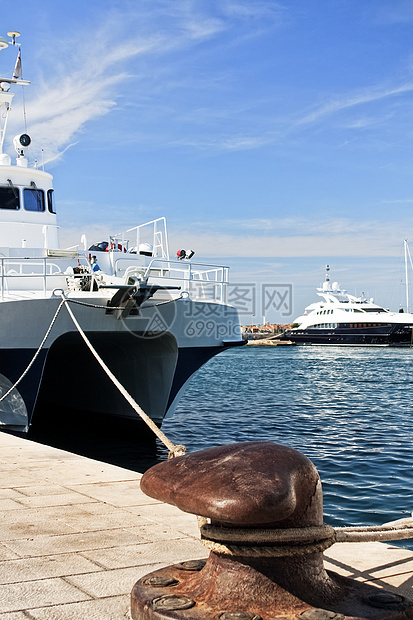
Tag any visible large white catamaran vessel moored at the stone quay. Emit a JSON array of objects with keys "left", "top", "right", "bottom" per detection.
[{"left": 0, "top": 32, "right": 243, "bottom": 432}]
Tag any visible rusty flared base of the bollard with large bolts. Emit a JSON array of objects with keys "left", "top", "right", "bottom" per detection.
[{"left": 131, "top": 553, "right": 413, "bottom": 620}]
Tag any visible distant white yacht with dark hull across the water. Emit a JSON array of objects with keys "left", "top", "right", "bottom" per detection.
[{"left": 282, "top": 265, "right": 413, "bottom": 346}]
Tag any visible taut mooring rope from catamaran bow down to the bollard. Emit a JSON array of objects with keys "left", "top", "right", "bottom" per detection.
[{"left": 60, "top": 291, "right": 186, "bottom": 459}]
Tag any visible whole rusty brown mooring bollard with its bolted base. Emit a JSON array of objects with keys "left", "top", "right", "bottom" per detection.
[{"left": 131, "top": 442, "right": 413, "bottom": 620}]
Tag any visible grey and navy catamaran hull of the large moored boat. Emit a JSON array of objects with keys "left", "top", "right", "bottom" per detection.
[{"left": 0, "top": 298, "right": 243, "bottom": 432}]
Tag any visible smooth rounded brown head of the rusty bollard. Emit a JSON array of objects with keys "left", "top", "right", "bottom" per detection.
[{"left": 141, "top": 441, "right": 323, "bottom": 527}]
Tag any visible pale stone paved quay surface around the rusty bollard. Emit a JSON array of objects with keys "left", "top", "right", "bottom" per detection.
[{"left": 0, "top": 432, "right": 413, "bottom": 620}]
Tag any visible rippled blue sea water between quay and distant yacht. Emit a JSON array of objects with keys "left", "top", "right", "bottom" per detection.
[{"left": 159, "top": 346, "right": 413, "bottom": 536}]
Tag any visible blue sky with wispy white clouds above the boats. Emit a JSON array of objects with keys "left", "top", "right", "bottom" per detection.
[{"left": 0, "top": 0, "right": 413, "bottom": 322}]
